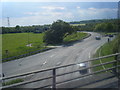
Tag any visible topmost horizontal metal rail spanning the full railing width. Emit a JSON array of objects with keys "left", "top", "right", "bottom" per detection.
[{"left": 3, "top": 53, "right": 120, "bottom": 80}]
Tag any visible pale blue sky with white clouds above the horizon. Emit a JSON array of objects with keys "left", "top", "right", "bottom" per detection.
[{"left": 0, "top": 0, "right": 118, "bottom": 26}]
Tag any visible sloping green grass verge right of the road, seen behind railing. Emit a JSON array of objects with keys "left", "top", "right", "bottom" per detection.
[{"left": 92, "top": 34, "right": 120, "bottom": 71}]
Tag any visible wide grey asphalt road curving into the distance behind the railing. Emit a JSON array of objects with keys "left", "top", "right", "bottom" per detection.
[{"left": 2, "top": 32, "right": 107, "bottom": 87}]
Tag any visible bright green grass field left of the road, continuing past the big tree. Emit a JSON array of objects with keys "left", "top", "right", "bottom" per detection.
[{"left": 2, "top": 32, "right": 87, "bottom": 62}]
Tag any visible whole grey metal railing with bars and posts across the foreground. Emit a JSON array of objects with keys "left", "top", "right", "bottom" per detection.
[{"left": 1, "top": 53, "right": 120, "bottom": 90}]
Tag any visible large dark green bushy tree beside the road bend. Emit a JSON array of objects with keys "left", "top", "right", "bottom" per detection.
[{"left": 43, "top": 20, "right": 73, "bottom": 44}]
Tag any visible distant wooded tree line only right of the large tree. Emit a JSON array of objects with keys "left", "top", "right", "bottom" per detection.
[{"left": 70, "top": 19, "right": 120, "bottom": 32}]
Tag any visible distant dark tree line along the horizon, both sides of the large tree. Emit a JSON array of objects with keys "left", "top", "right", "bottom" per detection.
[{"left": 2, "top": 19, "right": 120, "bottom": 34}]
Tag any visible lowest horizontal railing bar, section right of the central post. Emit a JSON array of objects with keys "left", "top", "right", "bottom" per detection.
[{"left": 56, "top": 65, "right": 120, "bottom": 84}]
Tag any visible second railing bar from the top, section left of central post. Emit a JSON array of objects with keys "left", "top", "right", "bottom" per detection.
[{"left": 2, "top": 76, "right": 53, "bottom": 89}]
